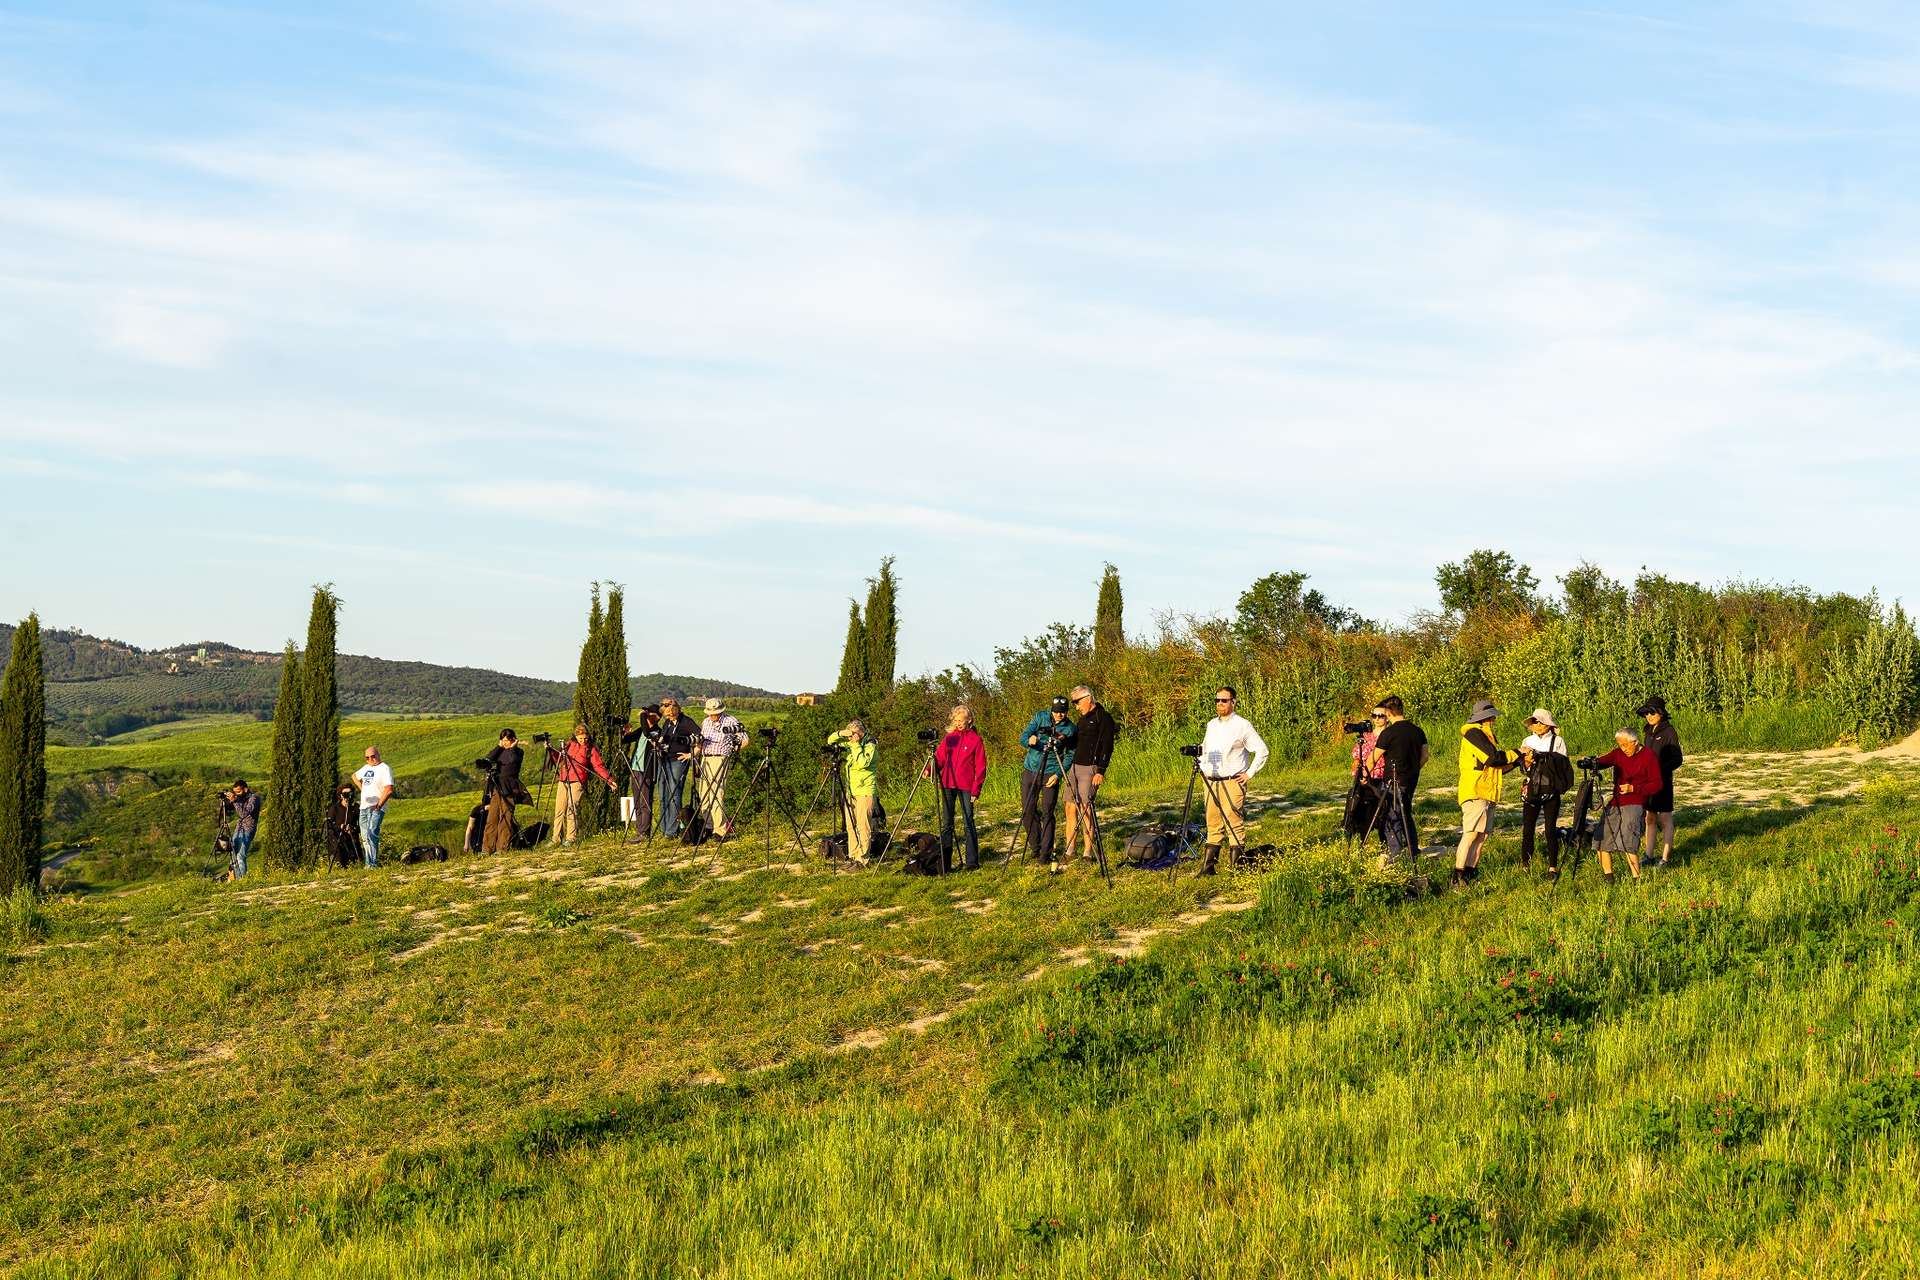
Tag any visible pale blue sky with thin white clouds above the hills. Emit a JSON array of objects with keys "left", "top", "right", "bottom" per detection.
[{"left": 0, "top": 0, "right": 1920, "bottom": 689}]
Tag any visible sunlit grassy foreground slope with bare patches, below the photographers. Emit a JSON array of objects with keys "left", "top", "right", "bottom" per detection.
[{"left": 11, "top": 758, "right": 1920, "bottom": 1276}]
